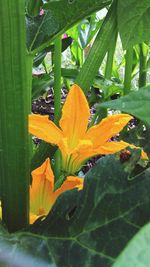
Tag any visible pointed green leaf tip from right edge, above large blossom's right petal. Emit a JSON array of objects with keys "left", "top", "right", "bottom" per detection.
[{"left": 101, "top": 86, "right": 150, "bottom": 125}]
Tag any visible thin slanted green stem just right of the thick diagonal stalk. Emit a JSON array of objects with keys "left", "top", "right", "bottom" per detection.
[{"left": 105, "top": 32, "right": 117, "bottom": 80}]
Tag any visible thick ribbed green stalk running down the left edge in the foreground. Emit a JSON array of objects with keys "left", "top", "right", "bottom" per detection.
[{"left": 0, "top": 0, "right": 32, "bottom": 232}]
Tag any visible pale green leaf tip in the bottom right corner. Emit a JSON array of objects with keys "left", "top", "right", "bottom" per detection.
[{"left": 113, "top": 223, "right": 150, "bottom": 267}]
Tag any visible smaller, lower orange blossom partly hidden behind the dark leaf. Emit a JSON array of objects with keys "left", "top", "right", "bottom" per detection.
[{"left": 30, "top": 159, "right": 83, "bottom": 224}]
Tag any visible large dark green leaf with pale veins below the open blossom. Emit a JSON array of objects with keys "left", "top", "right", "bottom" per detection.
[{"left": 27, "top": 156, "right": 150, "bottom": 267}]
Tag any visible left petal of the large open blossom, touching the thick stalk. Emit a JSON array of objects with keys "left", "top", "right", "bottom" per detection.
[{"left": 29, "top": 114, "right": 63, "bottom": 144}]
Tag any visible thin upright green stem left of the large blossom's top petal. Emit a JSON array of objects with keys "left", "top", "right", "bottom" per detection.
[{"left": 53, "top": 36, "right": 62, "bottom": 124}]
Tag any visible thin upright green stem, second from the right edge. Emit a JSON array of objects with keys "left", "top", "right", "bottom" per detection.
[{"left": 124, "top": 47, "right": 133, "bottom": 95}]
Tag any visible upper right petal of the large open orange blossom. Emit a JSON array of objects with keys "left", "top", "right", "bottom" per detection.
[{"left": 85, "top": 114, "right": 132, "bottom": 148}]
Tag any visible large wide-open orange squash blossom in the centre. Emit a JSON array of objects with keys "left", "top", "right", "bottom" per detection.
[{"left": 29, "top": 84, "right": 146, "bottom": 174}]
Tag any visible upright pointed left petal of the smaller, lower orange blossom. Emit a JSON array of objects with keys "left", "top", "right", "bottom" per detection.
[{"left": 30, "top": 159, "right": 54, "bottom": 216}]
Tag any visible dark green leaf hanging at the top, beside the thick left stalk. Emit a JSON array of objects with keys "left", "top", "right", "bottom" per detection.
[{"left": 26, "top": 0, "right": 111, "bottom": 53}]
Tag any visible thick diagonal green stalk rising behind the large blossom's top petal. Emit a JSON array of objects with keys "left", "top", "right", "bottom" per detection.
[{"left": 76, "top": 1, "right": 117, "bottom": 93}]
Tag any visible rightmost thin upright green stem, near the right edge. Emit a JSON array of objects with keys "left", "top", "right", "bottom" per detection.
[{"left": 139, "top": 43, "right": 147, "bottom": 88}]
